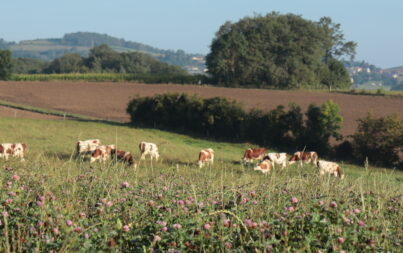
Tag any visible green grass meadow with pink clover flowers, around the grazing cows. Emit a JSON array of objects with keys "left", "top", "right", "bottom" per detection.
[{"left": 0, "top": 118, "right": 403, "bottom": 252}]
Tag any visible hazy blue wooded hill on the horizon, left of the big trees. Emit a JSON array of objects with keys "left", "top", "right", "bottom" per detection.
[{"left": 0, "top": 32, "right": 205, "bottom": 73}]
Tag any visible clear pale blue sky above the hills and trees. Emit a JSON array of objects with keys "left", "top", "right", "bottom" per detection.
[{"left": 0, "top": 0, "right": 403, "bottom": 68}]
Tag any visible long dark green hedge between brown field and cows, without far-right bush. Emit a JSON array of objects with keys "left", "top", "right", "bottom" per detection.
[{"left": 127, "top": 93, "right": 342, "bottom": 154}]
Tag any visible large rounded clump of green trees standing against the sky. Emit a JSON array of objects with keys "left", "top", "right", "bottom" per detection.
[{"left": 206, "top": 12, "right": 355, "bottom": 88}]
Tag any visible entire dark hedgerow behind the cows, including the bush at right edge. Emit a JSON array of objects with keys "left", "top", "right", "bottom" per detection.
[{"left": 127, "top": 93, "right": 403, "bottom": 167}]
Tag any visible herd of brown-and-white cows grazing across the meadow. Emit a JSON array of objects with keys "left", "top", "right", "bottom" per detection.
[{"left": 0, "top": 139, "right": 344, "bottom": 179}]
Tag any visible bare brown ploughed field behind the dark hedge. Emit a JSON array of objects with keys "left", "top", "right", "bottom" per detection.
[{"left": 0, "top": 82, "right": 403, "bottom": 135}]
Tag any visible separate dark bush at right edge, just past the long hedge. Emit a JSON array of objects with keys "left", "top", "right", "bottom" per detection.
[{"left": 352, "top": 114, "right": 403, "bottom": 166}]
